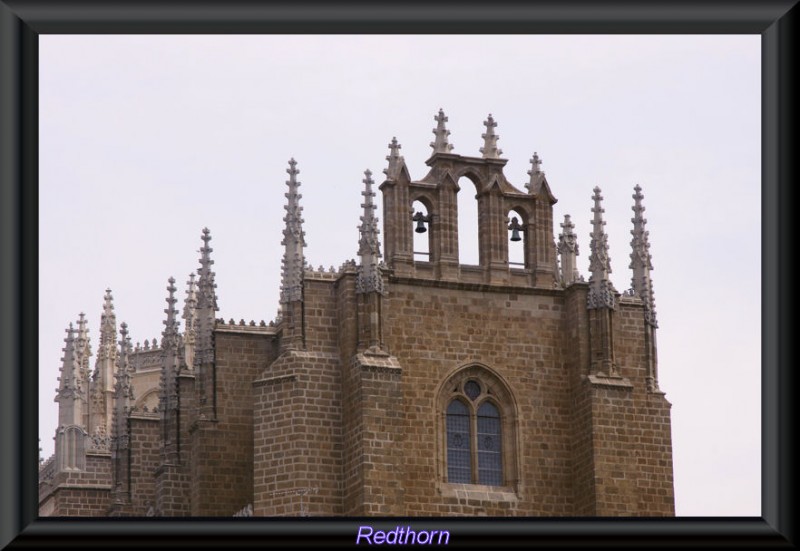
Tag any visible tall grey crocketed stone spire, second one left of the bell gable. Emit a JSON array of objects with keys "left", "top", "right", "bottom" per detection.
[{"left": 281, "top": 158, "right": 306, "bottom": 304}]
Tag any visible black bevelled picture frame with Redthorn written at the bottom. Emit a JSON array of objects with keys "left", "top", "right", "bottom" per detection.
[{"left": 0, "top": 0, "right": 798, "bottom": 548}]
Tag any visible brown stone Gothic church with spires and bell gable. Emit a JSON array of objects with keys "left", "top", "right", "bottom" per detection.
[{"left": 39, "top": 110, "right": 675, "bottom": 517}]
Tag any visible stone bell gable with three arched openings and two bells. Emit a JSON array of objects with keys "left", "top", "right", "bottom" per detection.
[{"left": 380, "top": 109, "right": 556, "bottom": 288}]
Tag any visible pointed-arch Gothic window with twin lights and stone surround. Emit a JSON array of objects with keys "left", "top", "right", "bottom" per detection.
[{"left": 439, "top": 366, "right": 517, "bottom": 486}]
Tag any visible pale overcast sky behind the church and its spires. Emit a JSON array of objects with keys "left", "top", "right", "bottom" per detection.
[{"left": 39, "top": 35, "right": 761, "bottom": 516}]
